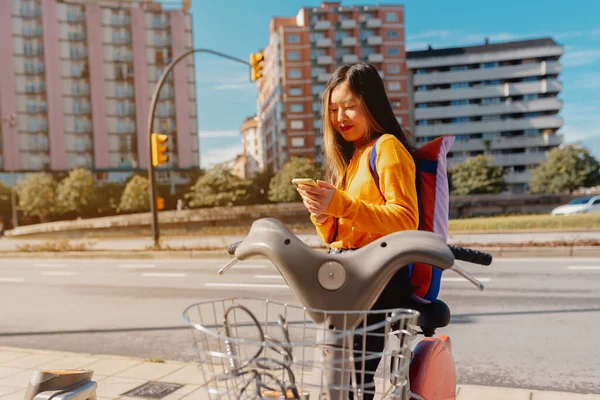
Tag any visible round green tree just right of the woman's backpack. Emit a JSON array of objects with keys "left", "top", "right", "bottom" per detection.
[{"left": 449, "top": 154, "right": 506, "bottom": 195}]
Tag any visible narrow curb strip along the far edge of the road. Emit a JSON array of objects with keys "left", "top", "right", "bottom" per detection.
[{"left": 0, "top": 246, "right": 600, "bottom": 259}]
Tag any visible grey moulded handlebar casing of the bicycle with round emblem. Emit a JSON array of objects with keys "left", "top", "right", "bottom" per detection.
[{"left": 219, "top": 218, "right": 464, "bottom": 329}]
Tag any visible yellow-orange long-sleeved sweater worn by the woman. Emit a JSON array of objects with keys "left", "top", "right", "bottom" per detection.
[{"left": 311, "top": 134, "right": 419, "bottom": 249}]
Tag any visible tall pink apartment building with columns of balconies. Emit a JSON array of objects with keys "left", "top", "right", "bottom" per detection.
[{"left": 0, "top": 0, "right": 199, "bottom": 181}]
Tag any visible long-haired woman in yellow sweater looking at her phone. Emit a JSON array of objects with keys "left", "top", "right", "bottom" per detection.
[{"left": 298, "top": 64, "right": 419, "bottom": 399}]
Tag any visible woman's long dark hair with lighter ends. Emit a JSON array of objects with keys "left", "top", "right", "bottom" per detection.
[{"left": 322, "top": 63, "right": 415, "bottom": 187}]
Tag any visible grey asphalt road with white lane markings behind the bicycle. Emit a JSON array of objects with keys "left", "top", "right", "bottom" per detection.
[{"left": 0, "top": 257, "right": 600, "bottom": 393}]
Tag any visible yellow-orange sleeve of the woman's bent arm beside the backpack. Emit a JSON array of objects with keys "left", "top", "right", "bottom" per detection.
[{"left": 327, "top": 137, "right": 419, "bottom": 235}]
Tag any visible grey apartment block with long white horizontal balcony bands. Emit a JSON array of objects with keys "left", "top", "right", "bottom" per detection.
[{"left": 407, "top": 38, "right": 563, "bottom": 193}]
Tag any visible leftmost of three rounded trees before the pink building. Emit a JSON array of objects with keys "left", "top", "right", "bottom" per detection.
[{"left": 17, "top": 172, "right": 56, "bottom": 222}]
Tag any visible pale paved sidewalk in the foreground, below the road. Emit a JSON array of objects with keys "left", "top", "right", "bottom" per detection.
[{"left": 0, "top": 347, "right": 600, "bottom": 400}]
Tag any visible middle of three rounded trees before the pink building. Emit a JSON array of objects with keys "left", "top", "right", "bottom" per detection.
[{"left": 56, "top": 168, "right": 98, "bottom": 215}]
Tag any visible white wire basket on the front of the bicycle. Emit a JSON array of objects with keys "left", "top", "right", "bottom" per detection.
[{"left": 184, "top": 297, "right": 419, "bottom": 400}]
